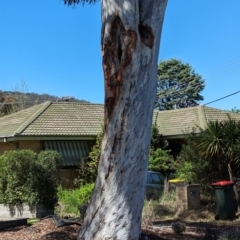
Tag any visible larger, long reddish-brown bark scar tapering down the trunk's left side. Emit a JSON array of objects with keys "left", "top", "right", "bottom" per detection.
[{"left": 103, "top": 15, "right": 137, "bottom": 123}]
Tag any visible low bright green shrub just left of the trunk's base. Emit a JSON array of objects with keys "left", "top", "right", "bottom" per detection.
[{"left": 58, "top": 183, "right": 94, "bottom": 216}]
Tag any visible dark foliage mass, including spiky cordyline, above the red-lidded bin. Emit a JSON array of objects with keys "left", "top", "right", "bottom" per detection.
[{"left": 177, "top": 119, "right": 240, "bottom": 199}]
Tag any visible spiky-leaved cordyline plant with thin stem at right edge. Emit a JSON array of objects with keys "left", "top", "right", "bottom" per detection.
[{"left": 195, "top": 118, "right": 240, "bottom": 201}]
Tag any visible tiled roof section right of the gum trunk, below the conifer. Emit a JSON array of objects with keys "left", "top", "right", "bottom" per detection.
[{"left": 157, "top": 105, "right": 240, "bottom": 137}]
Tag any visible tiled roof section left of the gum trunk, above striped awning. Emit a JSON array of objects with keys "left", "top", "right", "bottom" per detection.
[{"left": 0, "top": 102, "right": 104, "bottom": 138}]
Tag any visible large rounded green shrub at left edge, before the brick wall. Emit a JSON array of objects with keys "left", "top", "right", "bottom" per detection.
[{"left": 0, "top": 150, "right": 61, "bottom": 208}]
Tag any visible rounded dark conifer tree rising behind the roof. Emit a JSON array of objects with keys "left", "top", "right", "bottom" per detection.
[{"left": 155, "top": 59, "right": 205, "bottom": 110}]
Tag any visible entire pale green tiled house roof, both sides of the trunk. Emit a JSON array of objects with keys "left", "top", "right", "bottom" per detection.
[{"left": 0, "top": 102, "right": 240, "bottom": 138}]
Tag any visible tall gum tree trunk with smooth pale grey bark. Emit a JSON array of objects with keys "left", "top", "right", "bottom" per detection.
[{"left": 79, "top": 0, "right": 167, "bottom": 240}]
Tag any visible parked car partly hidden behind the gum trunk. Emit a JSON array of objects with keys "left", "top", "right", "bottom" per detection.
[{"left": 146, "top": 171, "right": 165, "bottom": 199}]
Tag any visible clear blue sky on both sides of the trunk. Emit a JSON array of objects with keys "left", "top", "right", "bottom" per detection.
[{"left": 0, "top": 0, "right": 240, "bottom": 110}]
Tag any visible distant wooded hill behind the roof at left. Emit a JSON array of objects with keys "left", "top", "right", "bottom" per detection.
[{"left": 0, "top": 90, "right": 90, "bottom": 116}]
